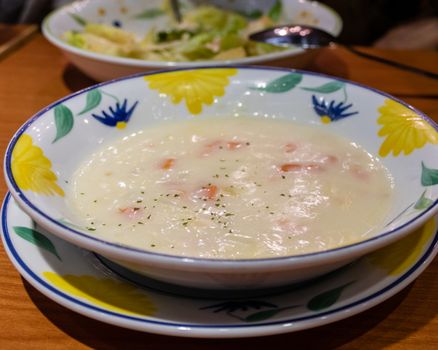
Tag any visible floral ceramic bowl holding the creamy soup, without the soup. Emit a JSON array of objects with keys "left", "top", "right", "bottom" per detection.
[{"left": 4, "top": 66, "right": 438, "bottom": 289}]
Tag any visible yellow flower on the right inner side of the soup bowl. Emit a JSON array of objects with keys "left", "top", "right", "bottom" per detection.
[{"left": 377, "top": 99, "right": 438, "bottom": 157}]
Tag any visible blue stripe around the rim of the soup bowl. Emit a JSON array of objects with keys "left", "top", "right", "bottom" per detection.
[{"left": 4, "top": 65, "right": 438, "bottom": 263}]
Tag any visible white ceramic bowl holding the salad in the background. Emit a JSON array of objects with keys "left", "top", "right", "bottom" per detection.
[{"left": 42, "top": 0, "right": 342, "bottom": 81}]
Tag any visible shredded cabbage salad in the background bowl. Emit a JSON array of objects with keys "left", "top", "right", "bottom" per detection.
[{"left": 63, "top": 6, "right": 284, "bottom": 62}]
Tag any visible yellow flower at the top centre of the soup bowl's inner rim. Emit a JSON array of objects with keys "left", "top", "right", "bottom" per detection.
[{"left": 144, "top": 68, "right": 237, "bottom": 114}]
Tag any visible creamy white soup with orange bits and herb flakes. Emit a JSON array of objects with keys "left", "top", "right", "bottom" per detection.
[{"left": 67, "top": 117, "right": 393, "bottom": 259}]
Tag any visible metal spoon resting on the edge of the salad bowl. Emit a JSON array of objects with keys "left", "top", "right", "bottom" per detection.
[{"left": 249, "top": 25, "right": 438, "bottom": 79}]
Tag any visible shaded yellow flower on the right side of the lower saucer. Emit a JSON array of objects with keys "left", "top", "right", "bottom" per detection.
[{"left": 368, "top": 218, "right": 436, "bottom": 276}]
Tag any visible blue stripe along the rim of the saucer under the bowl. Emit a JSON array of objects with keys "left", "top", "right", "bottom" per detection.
[{"left": 1, "top": 193, "right": 438, "bottom": 329}]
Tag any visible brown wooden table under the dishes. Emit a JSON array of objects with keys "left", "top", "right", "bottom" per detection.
[{"left": 0, "top": 34, "right": 438, "bottom": 350}]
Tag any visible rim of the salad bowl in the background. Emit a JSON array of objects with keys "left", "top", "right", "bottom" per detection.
[{"left": 41, "top": 0, "right": 343, "bottom": 69}]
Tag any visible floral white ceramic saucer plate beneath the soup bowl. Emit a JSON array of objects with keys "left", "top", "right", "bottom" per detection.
[{"left": 2, "top": 195, "right": 438, "bottom": 338}]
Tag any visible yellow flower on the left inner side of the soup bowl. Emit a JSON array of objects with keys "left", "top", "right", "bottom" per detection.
[{"left": 11, "top": 134, "right": 64, "bottom": 196}]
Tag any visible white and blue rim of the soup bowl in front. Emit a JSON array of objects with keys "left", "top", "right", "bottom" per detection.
[{"left": 3, "top": 65, "right": 438, "bottom": 269}]
